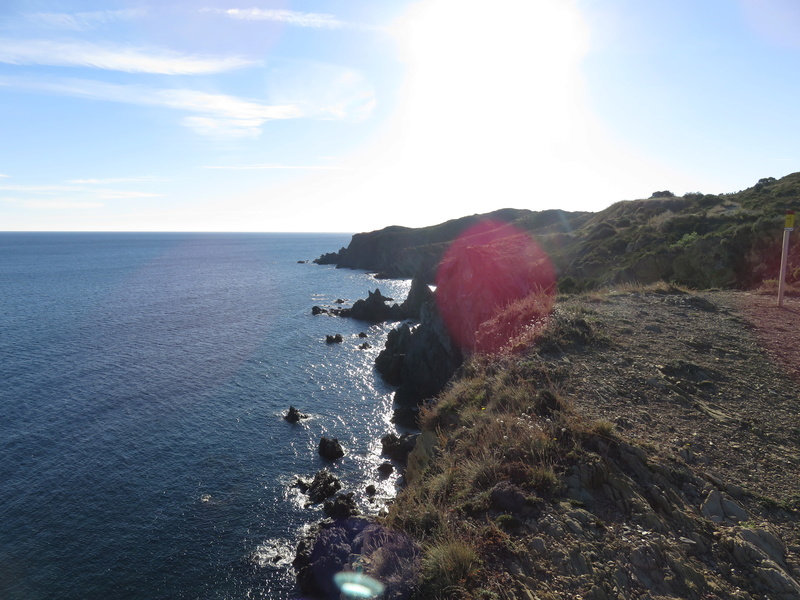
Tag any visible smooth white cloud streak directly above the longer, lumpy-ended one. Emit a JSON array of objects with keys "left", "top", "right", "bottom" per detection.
[{"left": 0, "top": 39, "right": 258, "bottom": 75}]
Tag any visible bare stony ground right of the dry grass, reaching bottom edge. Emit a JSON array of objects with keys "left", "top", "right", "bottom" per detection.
[{"left": 488, "top": 289, "right": 800, "bottom": 600}]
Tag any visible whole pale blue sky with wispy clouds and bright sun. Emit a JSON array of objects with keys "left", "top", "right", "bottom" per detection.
[{"left": 0, "top": 0, "right": 800, "bottom": 232}]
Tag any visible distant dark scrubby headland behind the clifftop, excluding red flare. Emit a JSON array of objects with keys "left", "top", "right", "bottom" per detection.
[{"left": 317, "top": 173, "right": 800, "bottom": 291}]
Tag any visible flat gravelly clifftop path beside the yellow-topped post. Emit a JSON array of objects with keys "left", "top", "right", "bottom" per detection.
[{"left": 559, "top": 290, "right": 800, "bottom": 546}]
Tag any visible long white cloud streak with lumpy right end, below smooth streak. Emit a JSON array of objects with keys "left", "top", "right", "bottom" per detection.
[{"left": 0, "top": 77, "right": 305, "bottom": 138}]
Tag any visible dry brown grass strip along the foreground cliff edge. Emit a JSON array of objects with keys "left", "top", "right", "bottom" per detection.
[{"left": 386, "top": 302, "right": 632, "bottom": 598}]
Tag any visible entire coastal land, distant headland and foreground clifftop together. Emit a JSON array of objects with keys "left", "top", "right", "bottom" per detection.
[{"left": 297, "top": 174, "right": 800, "bottom": 600}]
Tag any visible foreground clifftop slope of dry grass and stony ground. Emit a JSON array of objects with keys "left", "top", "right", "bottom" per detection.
[{"left": 300, "top": 284, "right": 800, "bottom": 600}]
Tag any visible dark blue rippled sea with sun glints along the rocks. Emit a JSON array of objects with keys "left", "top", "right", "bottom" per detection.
[{"left": 0, "top": 233, "right": 409, "bottom": 600}]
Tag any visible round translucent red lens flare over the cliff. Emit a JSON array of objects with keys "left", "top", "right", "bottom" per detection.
[{"left": 436, "top": 221, "right": 556, "bottom": 353}]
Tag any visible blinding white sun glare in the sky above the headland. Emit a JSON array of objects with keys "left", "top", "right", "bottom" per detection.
[{"left": 354, "top": 0, "right": 589, "bottom": 216}]
